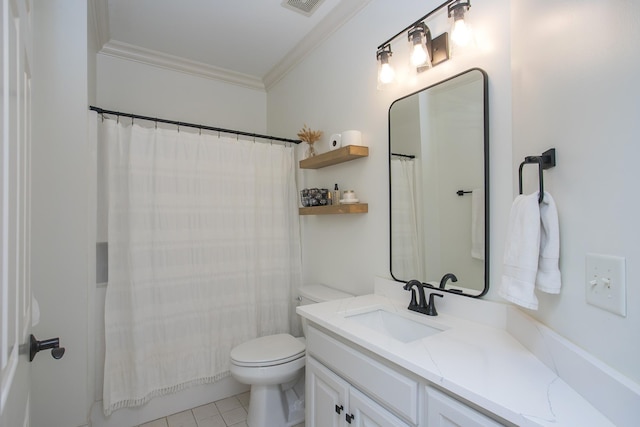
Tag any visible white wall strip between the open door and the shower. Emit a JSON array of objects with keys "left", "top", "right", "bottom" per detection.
[{"left": 31, "top": 0, "right": 90, "bottom": 426}]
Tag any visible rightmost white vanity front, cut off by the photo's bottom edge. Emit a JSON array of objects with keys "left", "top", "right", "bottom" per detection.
[{"left": 427, "top": 387, "right": 502, "bottom": 427}]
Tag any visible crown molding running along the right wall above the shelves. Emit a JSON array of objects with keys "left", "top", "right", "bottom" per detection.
[{"left": 262, "top": 0, "right": 371, "bottom": 90}]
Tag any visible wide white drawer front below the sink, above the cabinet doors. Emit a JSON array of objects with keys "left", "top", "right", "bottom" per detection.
[{"left": 307, "top": 326, "right": 418, "bottom": 424}]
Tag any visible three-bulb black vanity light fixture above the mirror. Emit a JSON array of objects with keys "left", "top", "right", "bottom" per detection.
[{"left": 376, "top": 0, "right": 473, "bottom": 89}]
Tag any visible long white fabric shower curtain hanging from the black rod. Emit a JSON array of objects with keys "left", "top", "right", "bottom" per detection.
[{"left": 101, "top": 120, "right": 301, "bottom": 415}]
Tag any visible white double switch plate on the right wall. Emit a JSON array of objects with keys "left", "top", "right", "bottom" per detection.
[{"left": 585, "top": 254, "right": 627, "bottom": 317}]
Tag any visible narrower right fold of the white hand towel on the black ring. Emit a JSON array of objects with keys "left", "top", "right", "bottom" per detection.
[{"left": 536, "top": 191, "right": 562, "bottom": 294}]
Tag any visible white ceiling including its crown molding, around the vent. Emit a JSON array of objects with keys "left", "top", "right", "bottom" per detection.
[{"left": 92, "top": 0, "right": 370, "bottom": 89}]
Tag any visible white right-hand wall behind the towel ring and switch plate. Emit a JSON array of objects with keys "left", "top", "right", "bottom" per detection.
[{"left": 511, "top": 0, "right": 640, "bottom": 382}]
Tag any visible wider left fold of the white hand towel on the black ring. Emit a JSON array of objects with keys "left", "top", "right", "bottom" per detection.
[{"left": 498, "top": 193, "right": 540, "bottom": 310}]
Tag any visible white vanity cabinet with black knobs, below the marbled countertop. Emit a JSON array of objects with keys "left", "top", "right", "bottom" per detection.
[{"left": 305, "top": 325, "right": 504, "bottom": 427}]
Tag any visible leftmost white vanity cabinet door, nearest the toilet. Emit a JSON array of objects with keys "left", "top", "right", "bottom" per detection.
[{"left": 305, "top": 357, "right": 349, "bottom": 427}]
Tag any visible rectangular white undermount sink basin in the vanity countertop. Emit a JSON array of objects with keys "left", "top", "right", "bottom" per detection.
[{"left": 345, "top": 309, "right": 444, "bottom": 343}]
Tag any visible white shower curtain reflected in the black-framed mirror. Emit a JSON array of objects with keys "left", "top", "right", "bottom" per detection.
[{"left": 391, "top": 158, "right": 424, "bottom": 280}]
